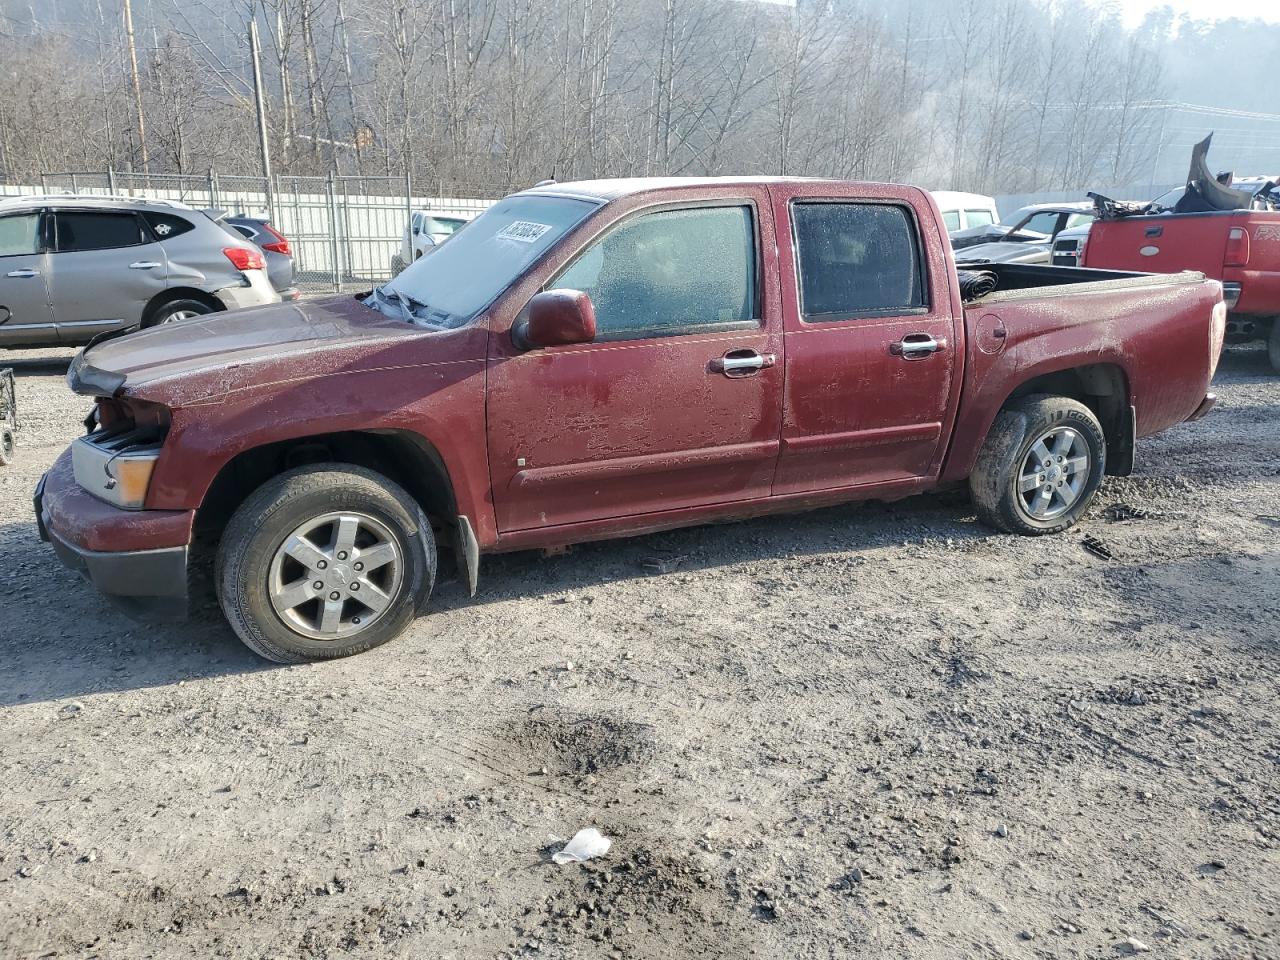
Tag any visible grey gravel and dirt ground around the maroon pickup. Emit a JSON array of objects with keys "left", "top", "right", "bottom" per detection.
[{"left": 0, "top": 343, "right": 1280, "bottom": 960}]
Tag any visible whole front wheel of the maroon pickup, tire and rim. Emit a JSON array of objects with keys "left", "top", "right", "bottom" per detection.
[{"left": 216, "top": 463, "right": 435, "bottom": 663}]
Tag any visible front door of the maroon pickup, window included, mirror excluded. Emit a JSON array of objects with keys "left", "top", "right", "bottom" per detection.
[{"left": 488, "top": 199, "right": 782, "bottom": 532}]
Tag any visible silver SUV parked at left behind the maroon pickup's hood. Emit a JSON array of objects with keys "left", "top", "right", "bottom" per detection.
[{"left": 0, "top": 195, "right": 280, "bottom": 347}]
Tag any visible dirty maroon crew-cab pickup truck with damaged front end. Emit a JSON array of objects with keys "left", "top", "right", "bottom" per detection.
[{"left": 36, "top": 178, "right": 1225, "bottom": 662}]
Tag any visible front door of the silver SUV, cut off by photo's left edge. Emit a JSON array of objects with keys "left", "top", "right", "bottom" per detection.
[{"left": 0, "top": 211, "right": 58, "bottom": 347}]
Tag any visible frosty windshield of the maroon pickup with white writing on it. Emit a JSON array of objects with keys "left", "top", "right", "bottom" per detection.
[{"left": 365, "top": 195, "right": 599, "bottom": 328}]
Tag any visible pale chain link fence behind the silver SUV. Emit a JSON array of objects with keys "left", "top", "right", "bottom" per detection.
[{"left": 0, "top": 170, "right": 508, "bottom": 293}]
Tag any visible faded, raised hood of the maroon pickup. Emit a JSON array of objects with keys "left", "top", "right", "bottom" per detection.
[{"left": 67, "top": 296, "right": 458, "bottom": 404}]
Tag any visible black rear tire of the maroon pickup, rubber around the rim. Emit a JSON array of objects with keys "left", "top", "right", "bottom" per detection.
[{"left": 969, "top": 394, "right": 1107, "bottom": 536}]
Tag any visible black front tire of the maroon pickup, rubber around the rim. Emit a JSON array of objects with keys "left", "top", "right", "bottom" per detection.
[{"left": 215, "top": 463, "right": 436, "bottom": 663}]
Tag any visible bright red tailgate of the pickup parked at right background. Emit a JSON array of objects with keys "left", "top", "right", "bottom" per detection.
[{"left": 1084, "top": 212, "right": 1236, "bottom": 280}]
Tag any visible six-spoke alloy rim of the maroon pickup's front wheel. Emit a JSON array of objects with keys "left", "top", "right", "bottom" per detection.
[{"left": 268, "top": 511, "right": 404, "bottom": 640}]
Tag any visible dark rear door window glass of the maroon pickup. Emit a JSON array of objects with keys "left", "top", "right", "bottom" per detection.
[{"left": 791, "top": 202, "right": 927, "bottom": 321}]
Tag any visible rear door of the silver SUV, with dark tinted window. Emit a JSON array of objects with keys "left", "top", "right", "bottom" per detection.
[{"left": 49, "top": 210, "right": 168, "bottom": 343}]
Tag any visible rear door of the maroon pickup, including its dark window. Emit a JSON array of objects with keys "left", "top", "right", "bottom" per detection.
[{"left": 773, "top": 184, "right": 964, "bottom": 495}]
